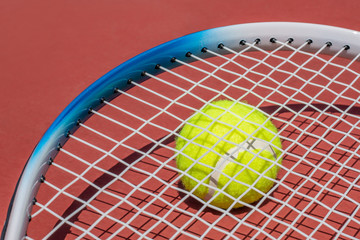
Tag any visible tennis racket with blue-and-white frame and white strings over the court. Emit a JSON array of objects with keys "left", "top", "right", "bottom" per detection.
[{"left": 2, "top": 23, "right": 360, "bottom": 240}]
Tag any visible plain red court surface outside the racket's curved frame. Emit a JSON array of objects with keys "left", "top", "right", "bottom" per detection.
[{"left": 0, "top": 0, "right": 360, "bottom": 236}]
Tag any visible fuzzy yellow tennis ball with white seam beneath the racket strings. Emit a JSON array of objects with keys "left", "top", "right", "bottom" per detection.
[{"left": 175, "top": 100, "right": 281, "bottom": 209}]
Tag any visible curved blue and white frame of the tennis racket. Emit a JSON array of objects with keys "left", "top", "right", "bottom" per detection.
[{"left": 1, "top": 22, "right": 360, "bottom": 240}]
